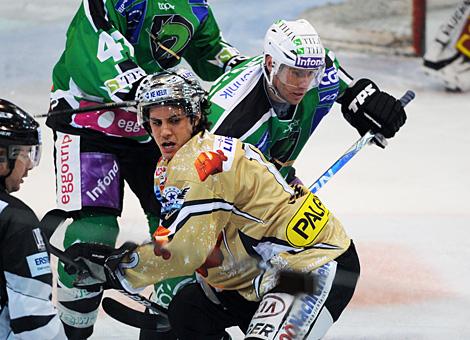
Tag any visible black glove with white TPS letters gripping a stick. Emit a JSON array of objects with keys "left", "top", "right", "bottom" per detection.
[{"left": 338, "top": 79, "right": 406, "bottom": 138}]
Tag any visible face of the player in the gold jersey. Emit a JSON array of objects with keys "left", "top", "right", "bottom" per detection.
[{"left": 149, "top": 106, "right": 198, "bottom": 160}]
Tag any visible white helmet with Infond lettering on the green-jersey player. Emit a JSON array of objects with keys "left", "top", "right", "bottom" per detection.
[{"left": 264, "top": 19, "right": 325, "bottom": 88}]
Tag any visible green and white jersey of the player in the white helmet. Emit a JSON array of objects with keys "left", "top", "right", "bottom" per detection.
[{"left": 209, "top": 50, "right": 352, "bottom": 176}]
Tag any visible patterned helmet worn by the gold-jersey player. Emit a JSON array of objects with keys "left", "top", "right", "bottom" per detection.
[{"left": 136, "top": 68, "right": 207, "bottom": 127}]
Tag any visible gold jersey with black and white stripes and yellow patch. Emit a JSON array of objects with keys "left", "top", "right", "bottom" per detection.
[{"left": 125, "top": 132, "right": 350, "bottom": 300}]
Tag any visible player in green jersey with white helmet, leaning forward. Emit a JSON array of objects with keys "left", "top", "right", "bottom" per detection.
[{"left": 209, "top": 20, "right": 406, "bottom": 182}]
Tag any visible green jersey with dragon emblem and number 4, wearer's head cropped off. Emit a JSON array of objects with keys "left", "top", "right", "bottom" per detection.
[{"left": 47, "top": 0, "right": 239, "bottom": 138}]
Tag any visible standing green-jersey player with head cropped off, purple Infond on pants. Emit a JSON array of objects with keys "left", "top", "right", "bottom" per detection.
[{"left": 47, "top": 0, "right": 241, "bottom": 339}]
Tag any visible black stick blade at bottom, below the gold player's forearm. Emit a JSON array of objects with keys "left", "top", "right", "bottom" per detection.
[{"left": 101, "top": 297, "right": 171, "bottom": 332}]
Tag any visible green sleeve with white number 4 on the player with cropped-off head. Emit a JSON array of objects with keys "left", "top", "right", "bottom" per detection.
[{"left": 63, "top": 1, "right": 145, "bottom": 102}]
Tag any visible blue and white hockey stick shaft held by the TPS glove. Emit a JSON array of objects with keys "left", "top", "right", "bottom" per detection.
[{"left": 308, "top": 90, "right": 415, "bottom": 193}]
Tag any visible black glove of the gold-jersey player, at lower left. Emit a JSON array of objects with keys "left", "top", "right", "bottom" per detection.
[{"left": 64, "top": 242, "right": 137, "bottom": 292}]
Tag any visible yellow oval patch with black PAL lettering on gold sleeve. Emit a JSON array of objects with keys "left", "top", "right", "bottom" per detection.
[{"left": 286, "top": 193, "right": 330, "bottom": 247}]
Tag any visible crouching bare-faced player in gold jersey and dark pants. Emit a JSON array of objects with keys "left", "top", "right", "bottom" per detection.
[{"left": 67, "top": 70, "right": 360, "bottom": 340}]
